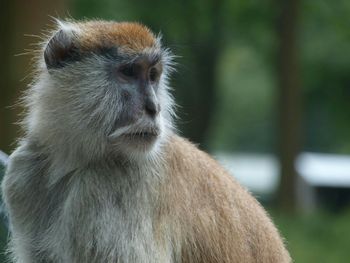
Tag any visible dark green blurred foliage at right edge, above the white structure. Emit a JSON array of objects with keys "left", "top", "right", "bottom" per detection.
[{"left": 300, "top": 0, "right": 350, "bottom": 153}]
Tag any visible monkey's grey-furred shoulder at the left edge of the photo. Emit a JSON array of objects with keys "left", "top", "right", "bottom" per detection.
[{"left": 1, "top": 141, "right": 54, "bottom": 229}]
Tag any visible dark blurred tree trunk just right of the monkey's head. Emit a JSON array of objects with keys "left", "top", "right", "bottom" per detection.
[{"left": 179, "top": 0, "right": 223, "bottom": 148}]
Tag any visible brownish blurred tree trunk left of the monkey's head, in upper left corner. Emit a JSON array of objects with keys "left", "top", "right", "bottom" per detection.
[{"left": 0, "top": 0, "right": 66, "bottom": 153}]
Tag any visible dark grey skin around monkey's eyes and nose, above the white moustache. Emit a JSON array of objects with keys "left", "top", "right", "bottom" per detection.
[{"left": 104, "top": 53, "right": 162, "bottom": 138}]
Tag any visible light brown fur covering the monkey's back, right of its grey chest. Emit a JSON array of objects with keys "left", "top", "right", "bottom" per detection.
[{"left": 158, "top": 136, "right": 291, "bottom": 263}]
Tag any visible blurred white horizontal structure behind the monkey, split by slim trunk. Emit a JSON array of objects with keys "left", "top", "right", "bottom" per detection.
[{"left": 214, "top": 153, "right": 350, "bottom": 210}]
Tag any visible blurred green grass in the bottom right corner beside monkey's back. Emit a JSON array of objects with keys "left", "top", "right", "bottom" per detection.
[{"left": 272, "top": 210, "right": 350, "bottom": 263}]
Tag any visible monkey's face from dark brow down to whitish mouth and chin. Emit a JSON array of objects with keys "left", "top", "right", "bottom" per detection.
[{"left": 107, "top": 52, "right": 165, "bottom": 152}]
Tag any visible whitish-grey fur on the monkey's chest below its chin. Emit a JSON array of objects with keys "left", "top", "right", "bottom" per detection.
[{"left": 41, "top": 165, "right": 172, "bottom": 263}]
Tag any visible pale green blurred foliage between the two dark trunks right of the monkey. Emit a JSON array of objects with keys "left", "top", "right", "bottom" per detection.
[{"left": 208, "top": 45, "right": 276, "bottom": 152}]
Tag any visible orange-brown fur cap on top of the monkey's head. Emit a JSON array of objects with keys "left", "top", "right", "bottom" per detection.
[{"left": 74, "top": 21, "right": 157, "bottom": 52}]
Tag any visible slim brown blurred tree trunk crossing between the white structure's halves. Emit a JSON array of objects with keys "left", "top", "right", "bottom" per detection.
[{"left": 277, "top": 0, "right": 301, "bottom": 212}]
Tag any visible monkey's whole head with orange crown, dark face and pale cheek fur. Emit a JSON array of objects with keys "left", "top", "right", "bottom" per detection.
[{"left": 27, "top": 21, "right": 173, "bottom": 162}]
